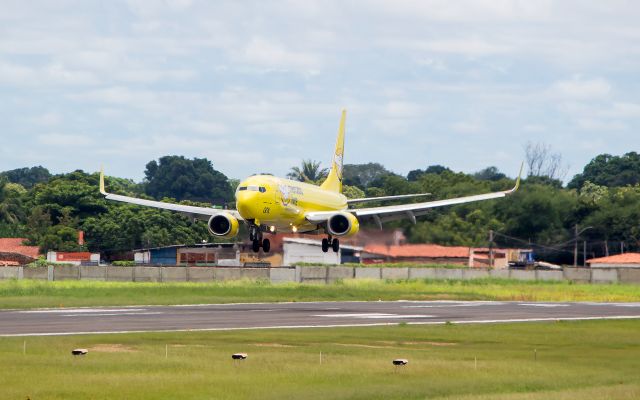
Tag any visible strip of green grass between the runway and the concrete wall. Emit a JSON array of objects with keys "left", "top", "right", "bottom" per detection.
[{"left": 0, "top": 279, "right": 640, "bottom": 309}]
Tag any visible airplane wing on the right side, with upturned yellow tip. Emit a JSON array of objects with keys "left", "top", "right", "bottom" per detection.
[{"left": 305, "top": 162, "right": 522, "bottom": 227}]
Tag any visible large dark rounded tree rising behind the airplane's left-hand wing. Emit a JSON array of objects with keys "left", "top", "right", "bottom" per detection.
[{"left": 144, "top": 156, "right": 233, "bottom": 204}]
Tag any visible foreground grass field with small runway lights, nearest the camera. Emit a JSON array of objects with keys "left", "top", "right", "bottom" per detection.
[{"left": 0, "top": 320, "right": 640, "bottom": 400}]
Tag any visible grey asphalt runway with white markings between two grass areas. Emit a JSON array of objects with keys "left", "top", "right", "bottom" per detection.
[{"left": 0, "top": 301, "right": 640, "bottom": 337}]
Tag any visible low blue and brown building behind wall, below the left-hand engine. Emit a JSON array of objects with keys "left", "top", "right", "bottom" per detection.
[{"left": 133, "top": 243, "right": 241, "bottom": 266}]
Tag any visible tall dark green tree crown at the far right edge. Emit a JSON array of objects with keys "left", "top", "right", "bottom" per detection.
[{"left": 568, "top": 151, "right": 640, "bottom": 189}]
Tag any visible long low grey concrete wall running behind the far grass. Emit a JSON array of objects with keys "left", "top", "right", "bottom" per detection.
[{"left": 0, "top": 266, "right": 640, "bottom": 284}]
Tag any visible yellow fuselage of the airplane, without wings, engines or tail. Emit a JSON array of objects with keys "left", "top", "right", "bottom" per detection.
[{"left": 235, "top": 175, "right": 347, "bottom": 232}]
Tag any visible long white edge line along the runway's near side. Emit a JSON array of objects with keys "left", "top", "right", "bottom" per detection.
[{"left": 0, "top": 315, "right": 640, "bottom": 337}]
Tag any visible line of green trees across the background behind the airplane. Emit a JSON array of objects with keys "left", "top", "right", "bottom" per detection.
[{"left": 0, "top": 151, "right": 640, "bottom": 262}]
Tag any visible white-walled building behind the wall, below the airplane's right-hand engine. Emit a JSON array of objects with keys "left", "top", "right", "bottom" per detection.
[{"left": 282, "top": 237, "right": 363, "bottom": 266}]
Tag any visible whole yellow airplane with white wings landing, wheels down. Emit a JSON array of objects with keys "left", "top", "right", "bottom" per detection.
[{"left": 100, "top": 110, "right": 522, "bottom": 253}]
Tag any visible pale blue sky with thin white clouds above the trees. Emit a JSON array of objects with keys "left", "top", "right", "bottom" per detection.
[{"left": 0, "top": 0, "right": 640, "bottom": 181}]
